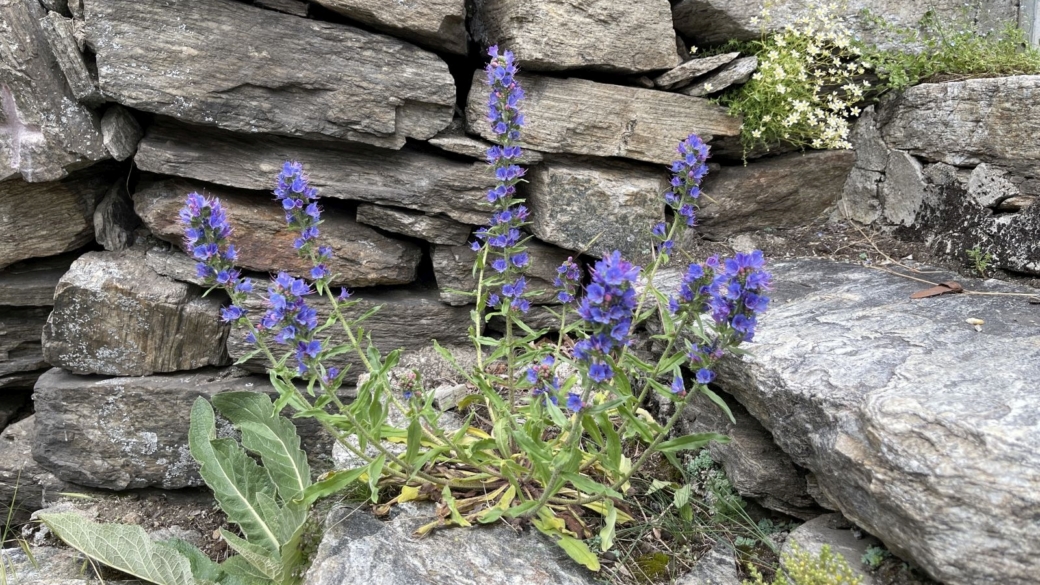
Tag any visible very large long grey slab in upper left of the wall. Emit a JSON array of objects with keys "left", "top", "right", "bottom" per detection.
[{"left": 85, "top": 0, "right": 456, "bottom": 149}]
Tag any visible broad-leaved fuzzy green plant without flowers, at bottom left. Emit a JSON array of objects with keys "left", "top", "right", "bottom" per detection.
[{"left": 40, "top": 392, "right": 314, "bottom": 585}]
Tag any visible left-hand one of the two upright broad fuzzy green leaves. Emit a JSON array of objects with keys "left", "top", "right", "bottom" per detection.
[{"left": 188, "top": 398, "right": 281, "bottom": 554}]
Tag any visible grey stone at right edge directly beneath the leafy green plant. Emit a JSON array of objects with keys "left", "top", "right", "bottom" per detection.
[{"left": 878, "top": 75, "right": 1040, "bottom": 172}]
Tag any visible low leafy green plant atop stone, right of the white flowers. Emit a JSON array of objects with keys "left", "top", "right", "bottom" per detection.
[{"left": 859, "top": 10, "right": 1040, "bottom": 90}]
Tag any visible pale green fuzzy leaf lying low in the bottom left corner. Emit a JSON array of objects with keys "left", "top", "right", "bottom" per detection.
[{"left": 38, "top": 512, "right": 196, "bottom": 585}]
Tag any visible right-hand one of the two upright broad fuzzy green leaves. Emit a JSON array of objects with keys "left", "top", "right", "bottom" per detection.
[{"left": 213, "top": 392, "right": 311, "bottom": 502}]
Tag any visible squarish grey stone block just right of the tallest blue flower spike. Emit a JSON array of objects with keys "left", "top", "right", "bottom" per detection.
[{"left": 521, "top": 157, "right": 669, "bottom": 258}]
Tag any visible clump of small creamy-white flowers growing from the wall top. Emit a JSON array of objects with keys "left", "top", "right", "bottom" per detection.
[{"left": 719, "top": 2, "right": 870, "bottom": 153}]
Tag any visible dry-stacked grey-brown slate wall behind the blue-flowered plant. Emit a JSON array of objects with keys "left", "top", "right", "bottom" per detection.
[{"left": 0, "top": 0, "right": 1019, "bottom": 508}]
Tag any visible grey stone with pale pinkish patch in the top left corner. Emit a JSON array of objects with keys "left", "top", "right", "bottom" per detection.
[{"left": 0, "top": 0, "right": 108, "bottom": 180}]
